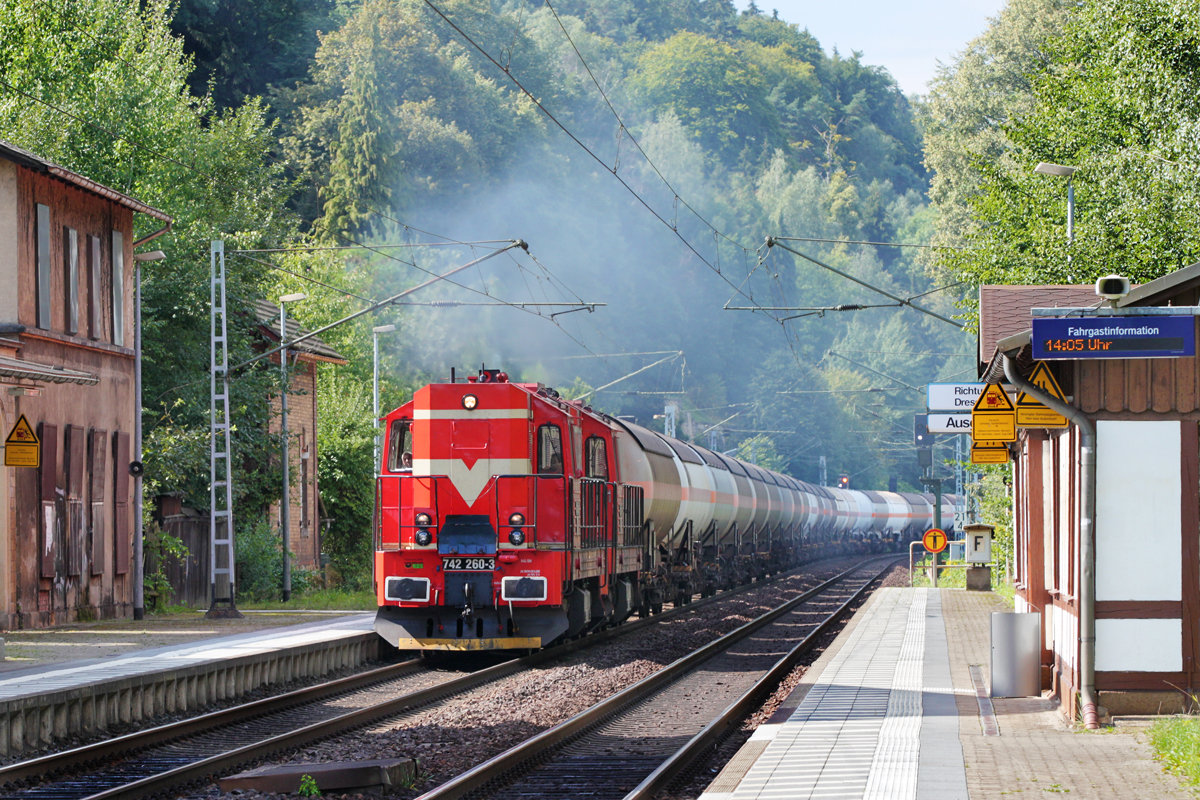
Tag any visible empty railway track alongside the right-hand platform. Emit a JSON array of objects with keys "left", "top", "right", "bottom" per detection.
[{"left": 418, "top": 560, "right": 894, "bottom": 800}]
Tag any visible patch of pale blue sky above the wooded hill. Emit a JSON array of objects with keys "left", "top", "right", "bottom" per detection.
[{"left": 737, "top": 0, "right": 1004, "bottom": 94}]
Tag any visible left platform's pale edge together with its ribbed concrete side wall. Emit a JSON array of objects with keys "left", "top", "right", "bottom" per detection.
[{"left": 0, "top": 612, "right": 379, "bottom": 757}]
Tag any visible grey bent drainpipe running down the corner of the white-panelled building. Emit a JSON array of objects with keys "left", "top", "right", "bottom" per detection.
[{"left": 1000, "top": 353, "right": 1100, "bottom": 730}]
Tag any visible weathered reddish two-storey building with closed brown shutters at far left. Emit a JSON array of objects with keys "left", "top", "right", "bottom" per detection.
[{"left": 0, "top": 136, "right": 172, "bottom": 628}]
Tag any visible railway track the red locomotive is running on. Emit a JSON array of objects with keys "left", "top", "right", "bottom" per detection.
[{"left": 0, "top": 567, "right": 883, "bottom": 800}]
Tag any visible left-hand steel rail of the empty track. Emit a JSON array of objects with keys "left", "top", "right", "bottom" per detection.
[{"left": 416, "top": 555, "right": 895, "bottom": 800}]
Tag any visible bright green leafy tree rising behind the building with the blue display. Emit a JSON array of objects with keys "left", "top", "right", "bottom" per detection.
[{"left": 935, "top": 0, "right": 1200, "bottom": 293}]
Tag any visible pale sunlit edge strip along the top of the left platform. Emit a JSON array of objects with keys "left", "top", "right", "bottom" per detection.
[{"left": 0, "top": 612, "right": 374, "bottom": 700}]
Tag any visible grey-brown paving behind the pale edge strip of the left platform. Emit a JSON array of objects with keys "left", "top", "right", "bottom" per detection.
[{"left": 0, "top": 609, "right": 369, "bottom": 674}]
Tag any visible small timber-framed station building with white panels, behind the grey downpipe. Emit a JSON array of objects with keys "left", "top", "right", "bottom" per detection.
[{"left": 979, "top": 264, "right": 1200, "bottom": 718}]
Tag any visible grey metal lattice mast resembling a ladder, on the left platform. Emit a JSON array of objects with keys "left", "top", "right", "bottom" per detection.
[{"left": 205, "top": 241, "right": 241, "bottom": 619}]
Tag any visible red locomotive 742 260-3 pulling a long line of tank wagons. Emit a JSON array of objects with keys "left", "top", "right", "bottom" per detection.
[{"left": 374, "top": 369, "right": 955, "bottom": 650}]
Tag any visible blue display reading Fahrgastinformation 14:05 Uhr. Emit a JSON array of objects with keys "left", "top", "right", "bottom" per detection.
[{"left": 1033, "top": 317, "right": 1196, "bottom": 361}]
